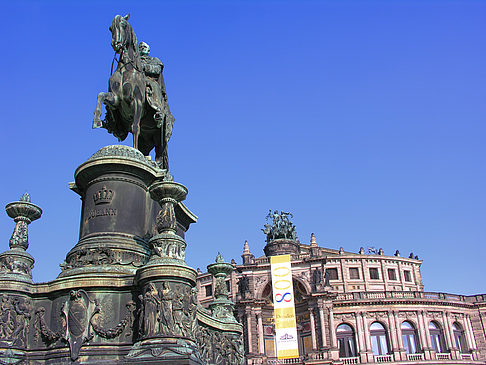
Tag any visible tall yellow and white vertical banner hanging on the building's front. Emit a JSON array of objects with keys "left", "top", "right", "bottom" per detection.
[{"left": 270, "top": 255, "right": 299, "bottom": 359}]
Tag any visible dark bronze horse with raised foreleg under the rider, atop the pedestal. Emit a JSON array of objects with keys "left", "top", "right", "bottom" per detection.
[{"left": 93, "top": 15, "right": 174, "bottom": 170}]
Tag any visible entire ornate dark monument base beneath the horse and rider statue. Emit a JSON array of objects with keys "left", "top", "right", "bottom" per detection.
[{"left": 0, "top": 146, "right": 244, "bottom": 365}]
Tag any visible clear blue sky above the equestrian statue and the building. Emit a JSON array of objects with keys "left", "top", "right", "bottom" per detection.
[{"left": 0, "top": 0, "right": 486, "bottom": 294}]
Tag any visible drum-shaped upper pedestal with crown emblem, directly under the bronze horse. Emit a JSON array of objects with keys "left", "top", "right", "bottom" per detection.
[{"left": 60, "top": 145, "right": 169, "bottom": 277}]
